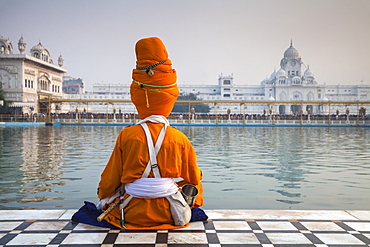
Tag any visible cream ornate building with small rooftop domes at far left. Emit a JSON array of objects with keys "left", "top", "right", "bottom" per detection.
[{"left": 0, "top": 37, "right": 67, "bottom": 114}]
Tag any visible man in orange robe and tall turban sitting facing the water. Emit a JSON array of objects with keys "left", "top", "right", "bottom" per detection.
[{"left": 98, "top": 38, "right": 203, "bottom": 229}]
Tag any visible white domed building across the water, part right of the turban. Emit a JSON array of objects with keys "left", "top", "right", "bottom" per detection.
[{"left": 180, "top": 42, "right": 370, "bottom": 114}]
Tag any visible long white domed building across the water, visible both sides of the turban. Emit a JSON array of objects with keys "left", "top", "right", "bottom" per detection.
[{"left": 66, "top": 42, "right": 370, "bottom": 114}]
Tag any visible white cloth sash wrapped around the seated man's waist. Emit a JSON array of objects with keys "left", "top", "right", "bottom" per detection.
[{"left": 125, "top": 178, "right": 178, "bottom": 198}]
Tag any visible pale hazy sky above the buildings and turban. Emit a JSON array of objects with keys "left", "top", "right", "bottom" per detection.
[{"left": 0, "top": 0, "right": 370, "bottom": 90}]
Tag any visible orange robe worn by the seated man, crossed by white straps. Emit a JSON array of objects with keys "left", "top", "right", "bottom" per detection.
[{"left": 98, "top": 122, "right": 204, "bottom": 229}]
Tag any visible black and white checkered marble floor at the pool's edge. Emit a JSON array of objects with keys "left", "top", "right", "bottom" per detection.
[{"left": 0, "top": 212, "right": 370, "bottom": 247}]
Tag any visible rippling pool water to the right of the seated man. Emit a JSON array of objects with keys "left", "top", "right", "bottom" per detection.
[{"left": 181, "top": 127, "right": 370, "bottom": 209}]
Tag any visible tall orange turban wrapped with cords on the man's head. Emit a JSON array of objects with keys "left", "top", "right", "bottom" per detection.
[{"left": 130, "top": 37, "right": 179, "bottom": 119}]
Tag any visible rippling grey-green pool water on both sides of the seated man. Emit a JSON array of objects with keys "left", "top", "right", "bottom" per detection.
[{"left": 0, "top": 126, "right": 370, "bottom": 209}]
